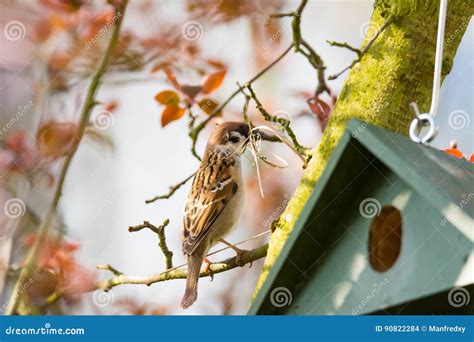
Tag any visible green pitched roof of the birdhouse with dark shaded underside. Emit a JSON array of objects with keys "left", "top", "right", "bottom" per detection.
[{"left": 249, "top": 119, "right": 474, "bottom": 314}]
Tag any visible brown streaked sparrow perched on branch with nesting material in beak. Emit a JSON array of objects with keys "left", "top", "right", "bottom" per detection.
[{"left": 181, "top": 122, "right": 251, "bottom": 309}]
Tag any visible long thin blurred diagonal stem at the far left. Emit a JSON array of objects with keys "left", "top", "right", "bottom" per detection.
[{"left": 5, "top": 0, "right": 128, "bottom": 315}]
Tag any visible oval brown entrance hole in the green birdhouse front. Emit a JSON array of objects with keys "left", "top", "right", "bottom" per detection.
[{"left": 369, "top": 205, "right": 402, "bottom": 272}]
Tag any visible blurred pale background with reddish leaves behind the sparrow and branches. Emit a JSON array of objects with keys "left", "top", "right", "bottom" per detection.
[{"left": 0, "top": 0, "right": 474, "bottom": 314}]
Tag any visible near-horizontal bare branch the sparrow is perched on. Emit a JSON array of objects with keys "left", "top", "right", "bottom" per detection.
[{"left": 97, "top": 244, "right": 268, "bottom": 291}]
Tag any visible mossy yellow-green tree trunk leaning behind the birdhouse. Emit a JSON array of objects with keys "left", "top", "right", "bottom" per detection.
[{"left": 254, "top": 0, "right": 474, "bottom": 296}]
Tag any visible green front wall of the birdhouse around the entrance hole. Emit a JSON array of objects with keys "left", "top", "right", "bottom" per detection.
[{"left": 287, "top": 166, "right": 472, "bottom": 315}]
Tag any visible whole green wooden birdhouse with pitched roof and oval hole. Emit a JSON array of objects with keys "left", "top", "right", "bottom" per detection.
[{"left": 249, "top": 120, "right": 474, "bottom": 315}]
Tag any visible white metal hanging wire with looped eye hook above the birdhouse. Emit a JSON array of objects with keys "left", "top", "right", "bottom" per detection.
[{"left": 410, "top": 0, "right": 448, "bottom": 144}]
